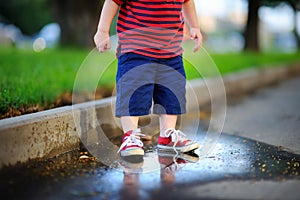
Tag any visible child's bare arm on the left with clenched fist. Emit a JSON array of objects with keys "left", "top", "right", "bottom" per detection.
[{"left": 94, "top": 0, "right": 119, "bottom": 53}]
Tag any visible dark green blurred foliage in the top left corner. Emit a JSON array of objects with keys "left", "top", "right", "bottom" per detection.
[{"left": 0, "top": 0, "right": 52, "bottom": 35}]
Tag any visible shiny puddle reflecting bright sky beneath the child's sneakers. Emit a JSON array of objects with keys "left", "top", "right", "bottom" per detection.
[{"left": 89, "top": 134, "right": 300, "bottom": 198}]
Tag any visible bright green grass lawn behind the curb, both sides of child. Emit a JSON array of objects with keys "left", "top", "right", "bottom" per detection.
[{"left": 0, "top": 48, "right": 300, "bottom": 118}]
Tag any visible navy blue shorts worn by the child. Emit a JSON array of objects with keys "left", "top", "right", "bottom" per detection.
[{"left": 115, "top": 53, "right": 186, "bottom": 117}]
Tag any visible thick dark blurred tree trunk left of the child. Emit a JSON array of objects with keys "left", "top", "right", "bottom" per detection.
[{"left": 48, "top": 0, "right": 105, "bottom": 47}]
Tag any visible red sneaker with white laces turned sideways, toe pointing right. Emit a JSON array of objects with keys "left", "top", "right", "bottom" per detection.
[{"left": 157, "top": 128, "right": 200, "bottom": 153}]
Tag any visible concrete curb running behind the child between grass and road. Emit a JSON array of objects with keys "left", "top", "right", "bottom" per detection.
[{"left": 0, "top": 65, "right": 300, "bottom": 169}]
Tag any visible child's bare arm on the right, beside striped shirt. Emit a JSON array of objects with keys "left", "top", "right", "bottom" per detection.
[{"left": 182, "top": 0, "right": 203, "bottom": 52}]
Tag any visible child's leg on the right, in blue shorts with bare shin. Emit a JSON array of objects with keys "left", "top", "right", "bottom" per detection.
[{"left": 153, "top": 56, "right": 186, "bottom": 136}]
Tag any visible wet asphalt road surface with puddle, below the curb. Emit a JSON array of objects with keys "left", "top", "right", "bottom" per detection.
[{"left": 0, "top": 77, "right": 300, "bottom": 199}]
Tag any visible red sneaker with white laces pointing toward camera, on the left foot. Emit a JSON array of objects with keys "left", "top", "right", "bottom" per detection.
[{"left": 118, "top": 129, "right": 144, "bottom": 156}]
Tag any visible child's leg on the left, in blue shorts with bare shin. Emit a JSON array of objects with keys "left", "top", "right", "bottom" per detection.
[{"left": 115, "top": 53, "right": 157, "bottom": 133}]
